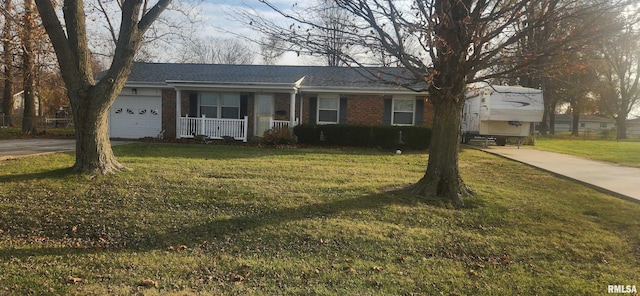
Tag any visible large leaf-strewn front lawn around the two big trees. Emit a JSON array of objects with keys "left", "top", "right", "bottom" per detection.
[{"left": 0, "top": 143, "right": 640, "bottom": 295}]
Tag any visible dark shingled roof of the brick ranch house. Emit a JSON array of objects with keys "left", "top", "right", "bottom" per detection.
[{"left": 122, "top": 63, "right": 425, "bottom": 89}]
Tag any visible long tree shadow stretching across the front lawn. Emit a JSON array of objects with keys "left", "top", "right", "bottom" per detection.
[{"left": 0, "top": 188, "right": 482, "bottom": 259}]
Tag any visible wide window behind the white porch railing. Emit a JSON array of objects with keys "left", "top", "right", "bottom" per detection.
[{"left": 199, "top": 93, "right": 240, "bottom": 119}]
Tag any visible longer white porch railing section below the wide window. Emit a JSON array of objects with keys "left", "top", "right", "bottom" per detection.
[{"left": 178, "top": 115, "right": 249, "bottom": 142}]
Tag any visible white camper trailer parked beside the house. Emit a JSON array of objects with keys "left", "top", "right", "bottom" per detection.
[{"left": 461, "top": 85, "right": 544, "bottom": 146}]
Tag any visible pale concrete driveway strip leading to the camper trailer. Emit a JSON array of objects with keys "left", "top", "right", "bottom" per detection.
[{"left": 482, "top": 146, "right": 640, "bottom": 202}]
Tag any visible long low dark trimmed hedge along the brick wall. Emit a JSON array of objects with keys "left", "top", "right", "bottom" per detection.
[{"left": 293, "top": 124, "right": 431, "bottom": 149}]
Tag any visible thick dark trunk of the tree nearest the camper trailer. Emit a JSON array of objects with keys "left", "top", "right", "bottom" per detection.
[{"left": 411, "top": 87, "right": 473, "bottom": 207}]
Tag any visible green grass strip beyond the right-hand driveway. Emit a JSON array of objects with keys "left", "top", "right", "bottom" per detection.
[{"left": 535, "top": 138, "right": 640, "bottom": 167}]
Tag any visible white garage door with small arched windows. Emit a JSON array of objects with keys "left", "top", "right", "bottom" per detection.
[{"left": 109, "top": 96, "right": 162, "bottom": 139}]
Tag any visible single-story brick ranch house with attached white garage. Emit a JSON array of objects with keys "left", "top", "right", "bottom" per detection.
[{"left": 109, "top": 63, "right": 433, "bottom": 141}]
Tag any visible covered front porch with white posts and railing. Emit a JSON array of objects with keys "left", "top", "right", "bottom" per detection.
[{"left": 172, "top": 82, "right": 299, "bottom": 142}]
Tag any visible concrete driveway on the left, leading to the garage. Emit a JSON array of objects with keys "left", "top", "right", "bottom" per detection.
[{"left": 0, "top": 139, "right": 131, "bottom": 160}]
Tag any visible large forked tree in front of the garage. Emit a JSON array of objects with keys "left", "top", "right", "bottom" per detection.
[{"left": 36, "top": 0, "right": 171, "bottom": 174}]
